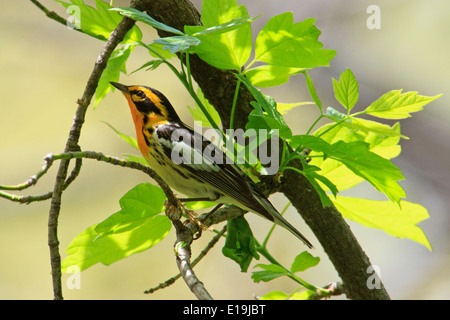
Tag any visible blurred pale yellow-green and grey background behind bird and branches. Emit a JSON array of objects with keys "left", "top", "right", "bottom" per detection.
[{"left": 0, "top": 0, "right": 450, "bottom": 299}]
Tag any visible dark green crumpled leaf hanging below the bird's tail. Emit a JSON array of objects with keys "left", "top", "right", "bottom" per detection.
[{"left": 222, "top": 217, "right": 259, "bottom": 272}]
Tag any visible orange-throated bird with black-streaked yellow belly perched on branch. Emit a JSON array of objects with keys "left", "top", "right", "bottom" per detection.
[{"left": 110, "top": 82, "right": 313, "bottom": 248}]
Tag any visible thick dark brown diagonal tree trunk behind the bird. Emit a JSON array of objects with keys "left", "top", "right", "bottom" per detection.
[{"left": 139, "top": 0, "right": 389, "bottom": 300}]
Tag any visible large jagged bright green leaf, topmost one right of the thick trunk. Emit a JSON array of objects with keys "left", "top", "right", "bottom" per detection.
[{"left": 255, "top": 12, "right": 336, "bottom": 68}]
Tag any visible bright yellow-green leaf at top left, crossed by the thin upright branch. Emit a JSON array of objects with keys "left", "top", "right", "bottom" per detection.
[{"left": 55, "top": 0, "right": 142, "bottom": 43}]
